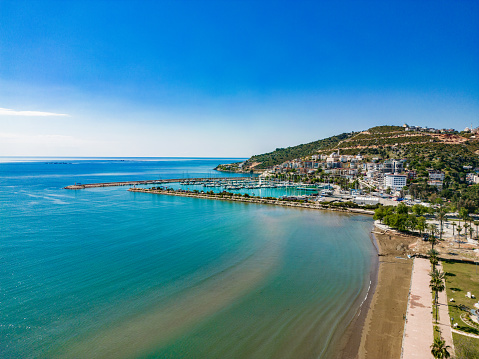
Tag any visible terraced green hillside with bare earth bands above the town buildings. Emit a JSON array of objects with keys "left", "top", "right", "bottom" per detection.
[{"left": 218, "top": 126, "right": 479, "bottom": 171}]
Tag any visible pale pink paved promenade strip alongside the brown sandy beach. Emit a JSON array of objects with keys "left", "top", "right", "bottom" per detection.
[{"left": 401, "top": 258, "right": 434, "bottom": 359}]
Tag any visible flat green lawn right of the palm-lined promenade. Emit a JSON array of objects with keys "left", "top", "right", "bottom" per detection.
[{"left": 443, "top": 261, "right": 479, "bottom": 343}]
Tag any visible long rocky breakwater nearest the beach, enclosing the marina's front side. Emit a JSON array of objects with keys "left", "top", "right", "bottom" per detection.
[{"left": 128, "top": 188, "right": 374, "bottom": 215}]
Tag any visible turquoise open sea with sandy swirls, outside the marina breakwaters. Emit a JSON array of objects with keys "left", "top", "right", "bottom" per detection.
[{"left": 0, "top": 157, "right": 377, "bottom": 358}]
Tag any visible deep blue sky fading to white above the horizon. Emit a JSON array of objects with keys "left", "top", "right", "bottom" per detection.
[{"left": 0, "top": 0, "right": 479, "bottom": 157}]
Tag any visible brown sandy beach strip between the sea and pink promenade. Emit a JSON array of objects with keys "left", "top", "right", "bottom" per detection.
[{"left": 358, "top": 229, "right": 417, "bottom": 359}]
